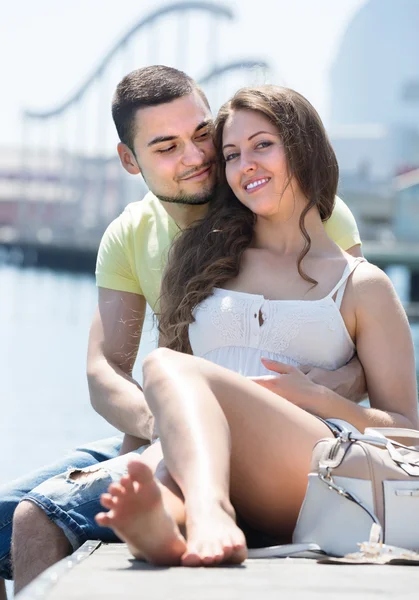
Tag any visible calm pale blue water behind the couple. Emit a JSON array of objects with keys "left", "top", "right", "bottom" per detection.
[{"left": 0, "top": 266, "right": 419, "bottom": 484}]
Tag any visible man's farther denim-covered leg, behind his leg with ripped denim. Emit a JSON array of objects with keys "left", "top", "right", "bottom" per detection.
[{"left": 0, "top": 436, "right": 122, "bottom": 600}]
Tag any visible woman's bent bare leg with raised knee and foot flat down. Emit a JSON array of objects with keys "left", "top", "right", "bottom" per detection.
[{"left": 144, "top": 349, "right": 332, "bottom": 564}]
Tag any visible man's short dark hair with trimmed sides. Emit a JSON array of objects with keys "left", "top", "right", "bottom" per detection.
[{"left": 112, "top": 65, "right": 209, "bottom": 151}]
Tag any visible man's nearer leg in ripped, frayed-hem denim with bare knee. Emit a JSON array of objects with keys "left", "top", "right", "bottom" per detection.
[{"left": 12, "top": 446, "right": 147, "bottom": 593}]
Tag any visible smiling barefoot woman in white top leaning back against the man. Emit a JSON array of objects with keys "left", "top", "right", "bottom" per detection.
[{"left": 97, "top": 86, "right": 418, "bottom": 566}]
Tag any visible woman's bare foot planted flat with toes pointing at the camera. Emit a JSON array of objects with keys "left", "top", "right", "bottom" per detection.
[{"left": 182, "top": 504, "right": 247, "bottom": 567}]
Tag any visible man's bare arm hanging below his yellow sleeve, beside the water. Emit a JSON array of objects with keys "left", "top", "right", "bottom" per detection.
[{"left": 87, "top": 288, "right": 153, "bottom": 449}]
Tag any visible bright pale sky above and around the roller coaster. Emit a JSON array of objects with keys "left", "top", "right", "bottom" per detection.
[{"left": 0, "top": 0, "right": 366, "bottom": 147}]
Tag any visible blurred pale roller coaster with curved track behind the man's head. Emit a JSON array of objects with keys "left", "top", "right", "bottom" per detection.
[{"left": 12, "top": 0, "right": 270, "bottom": 248}]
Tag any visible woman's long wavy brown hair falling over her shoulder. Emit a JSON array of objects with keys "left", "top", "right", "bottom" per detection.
[{"left": 159, "top": 85, "right": 339, "bottom": 353}]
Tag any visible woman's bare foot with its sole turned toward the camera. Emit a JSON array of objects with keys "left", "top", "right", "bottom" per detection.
[{"left": 96, "top": 457, "right": 186, "bottom": 565}]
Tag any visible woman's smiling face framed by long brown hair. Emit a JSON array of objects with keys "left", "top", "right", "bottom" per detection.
[{"left": 223, "top": 110, "right": 294, "bottom": 217}]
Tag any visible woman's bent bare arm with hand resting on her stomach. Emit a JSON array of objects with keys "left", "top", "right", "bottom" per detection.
[{"left": 255, "top": 263, "right": 419, "bottom": 431}]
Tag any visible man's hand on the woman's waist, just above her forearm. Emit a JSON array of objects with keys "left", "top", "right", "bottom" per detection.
[{"left": 300, "top": 355, "right": 367, "bottom": 403}]
